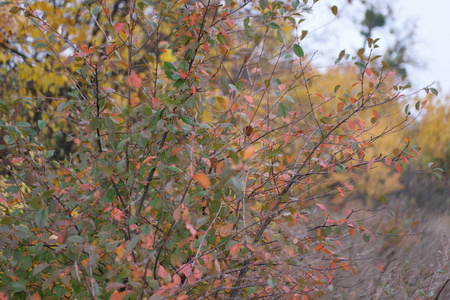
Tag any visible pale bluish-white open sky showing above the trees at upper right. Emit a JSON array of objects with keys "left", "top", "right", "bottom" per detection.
[{"left": 302, "top": 0, "right": 450, "bottom": 95}]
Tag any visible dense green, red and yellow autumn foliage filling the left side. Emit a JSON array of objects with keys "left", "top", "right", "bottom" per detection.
[{"left": 0, "top": 0, "right": 436, "bottom": 299}]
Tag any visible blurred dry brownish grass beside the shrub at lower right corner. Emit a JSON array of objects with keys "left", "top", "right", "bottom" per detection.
[{"left": 324, "top": 188, "right": 450, "bottom": 300}]
